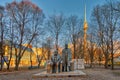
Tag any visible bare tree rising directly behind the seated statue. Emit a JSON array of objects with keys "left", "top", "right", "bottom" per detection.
[{"left": 46, "top": 14, "right": 65, "bottom": 50}]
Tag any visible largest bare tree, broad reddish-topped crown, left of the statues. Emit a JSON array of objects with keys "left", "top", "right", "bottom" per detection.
[{"left": 6, "top": 1, "right": 43, "bottom": 70}]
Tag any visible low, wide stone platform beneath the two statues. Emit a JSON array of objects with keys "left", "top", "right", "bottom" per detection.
[{"left": 32, "top": 70, "right": 86, "bottom": 80}]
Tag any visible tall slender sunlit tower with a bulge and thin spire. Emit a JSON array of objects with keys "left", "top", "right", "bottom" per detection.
[{"left": 83, "top": 5, "right": 88, "bottom": 58}]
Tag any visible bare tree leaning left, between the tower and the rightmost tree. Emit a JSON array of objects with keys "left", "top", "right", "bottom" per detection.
[{"left": 92, "top": 5, "right": 109, "bottom": 68}]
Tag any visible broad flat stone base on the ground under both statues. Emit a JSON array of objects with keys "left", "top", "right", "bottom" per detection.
[{"left": 32, "top": 70, "right": 87, "bottom": 80}]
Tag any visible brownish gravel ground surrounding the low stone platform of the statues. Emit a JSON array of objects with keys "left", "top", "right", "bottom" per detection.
[{"left": 0, "top": 68, "right": 120, "bottom": 80}]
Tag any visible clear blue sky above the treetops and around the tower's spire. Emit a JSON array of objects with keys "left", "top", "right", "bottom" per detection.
[{"left": 0, "top": 0, "right": 106, "bottom": 21}]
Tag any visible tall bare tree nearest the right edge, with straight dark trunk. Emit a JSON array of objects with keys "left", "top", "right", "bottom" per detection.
[{"left": 107, "top": 1, "right": 120, "bottom": 70}]
